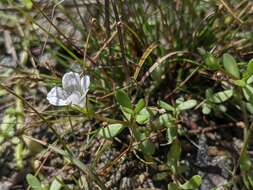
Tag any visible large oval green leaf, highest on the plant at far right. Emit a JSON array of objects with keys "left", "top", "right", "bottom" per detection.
[{"left": 223, "top": 53, "right": 240, "bottom": 79}]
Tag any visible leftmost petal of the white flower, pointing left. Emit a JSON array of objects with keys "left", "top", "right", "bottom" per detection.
[{"left": 47, "top": 87, "right": 68, "bottom": 106}]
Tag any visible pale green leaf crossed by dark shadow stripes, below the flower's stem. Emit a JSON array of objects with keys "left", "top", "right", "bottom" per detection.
[{"left": 98, "top": 124, "right": 125, "bottom": 139}]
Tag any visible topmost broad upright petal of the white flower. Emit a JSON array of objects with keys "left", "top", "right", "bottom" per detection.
[{"left": 62, "top": 72, "right": 81, "bottom": 95}]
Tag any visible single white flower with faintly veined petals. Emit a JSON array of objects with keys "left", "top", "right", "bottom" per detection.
[{"left": 47, "top": 72, "right": 90, "bottom": 107}]
